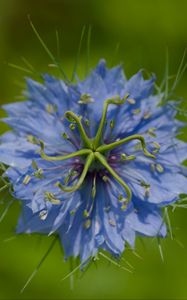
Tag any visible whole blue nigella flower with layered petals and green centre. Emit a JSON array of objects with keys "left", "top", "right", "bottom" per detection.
[{"left": 0, "top": 60, "right": 187, "bottom": 262}]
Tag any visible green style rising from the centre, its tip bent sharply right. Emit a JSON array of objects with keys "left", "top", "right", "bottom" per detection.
[{"left": 94, "top": 95, "right": 129, "bottom": 149}]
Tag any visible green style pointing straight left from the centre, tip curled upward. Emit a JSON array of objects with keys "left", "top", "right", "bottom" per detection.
[{"left": 40, "top": 141, "right": 92, "bottom": 161}]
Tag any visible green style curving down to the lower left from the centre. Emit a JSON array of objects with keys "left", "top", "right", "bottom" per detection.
[{"left": 56, "top": 152, "right": 94, "bottom": 192}]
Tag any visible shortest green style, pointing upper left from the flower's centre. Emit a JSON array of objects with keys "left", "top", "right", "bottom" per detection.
[{"left": 65, "top": 111, "right": 92, "bottom": 148}]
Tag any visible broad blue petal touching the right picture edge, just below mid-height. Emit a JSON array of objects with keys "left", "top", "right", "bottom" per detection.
[{"left": 119, "top": 161, "right": 187, "bottom": 205}]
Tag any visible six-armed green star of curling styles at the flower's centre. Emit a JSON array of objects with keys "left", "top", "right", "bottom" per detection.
[{"left": 40, "top": 95, "right": 155, "bottom": 202}]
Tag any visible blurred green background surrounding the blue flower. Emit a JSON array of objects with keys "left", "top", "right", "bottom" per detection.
[{"left": 0, "top": 0, "right": 187, "bottom": 299}]
